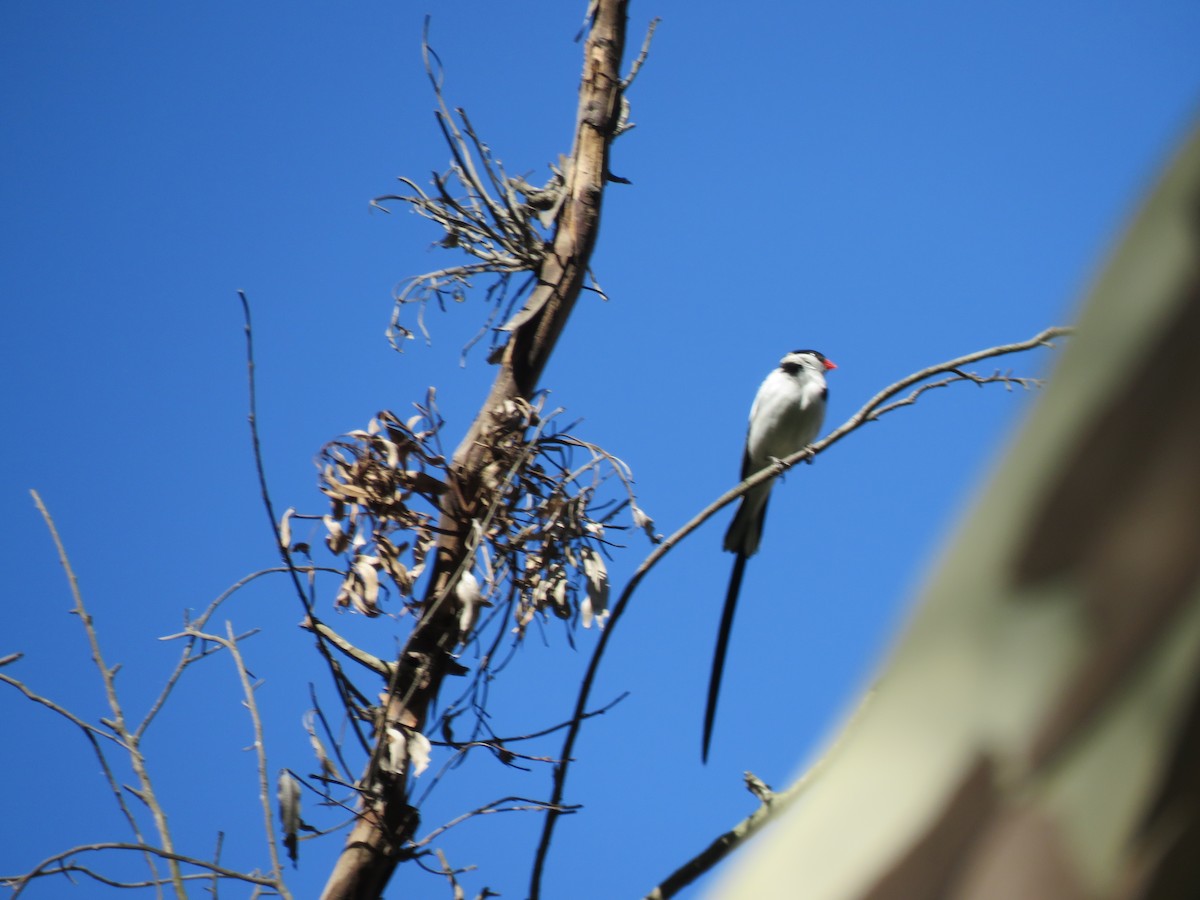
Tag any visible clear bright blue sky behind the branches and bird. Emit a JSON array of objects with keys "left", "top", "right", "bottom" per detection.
[{"left": 0, "top": 0, "right": 1200, "bottom": 898}]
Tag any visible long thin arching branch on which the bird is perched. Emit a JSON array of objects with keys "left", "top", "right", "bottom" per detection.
[{"left": 529, "top": 328, "right": 1072, "bottom": 900}]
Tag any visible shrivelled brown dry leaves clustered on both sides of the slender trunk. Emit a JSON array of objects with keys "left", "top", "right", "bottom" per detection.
[{"left": 292, "top": 391, "right": 654, "bottom": 643}]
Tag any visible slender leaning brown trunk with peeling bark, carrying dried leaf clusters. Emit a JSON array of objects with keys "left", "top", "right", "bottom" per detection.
[{"left": 322, "top": 0, "right": 628, "bottom": 900}]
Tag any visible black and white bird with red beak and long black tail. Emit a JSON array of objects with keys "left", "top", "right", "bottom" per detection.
[{"left": 702, "top": 350, "right": 836, "bottom": 762}]
